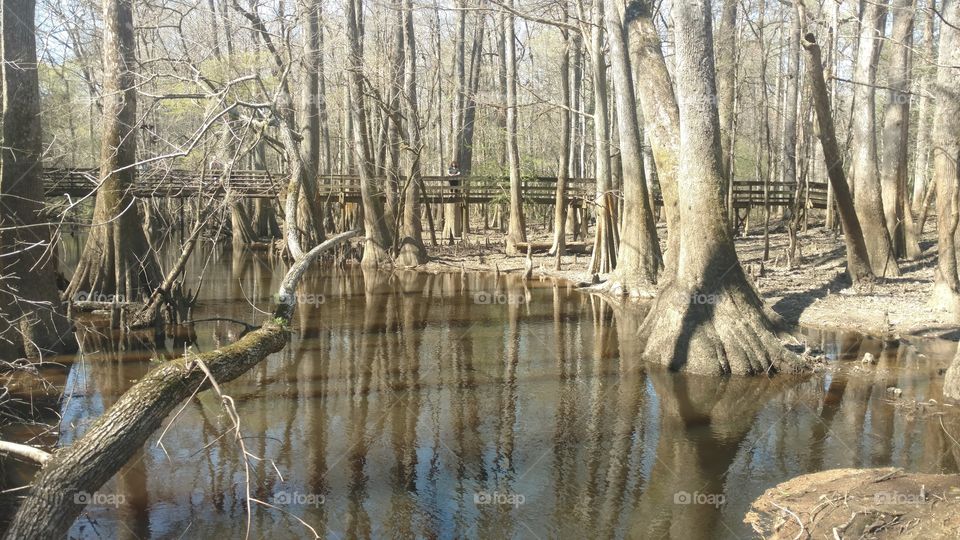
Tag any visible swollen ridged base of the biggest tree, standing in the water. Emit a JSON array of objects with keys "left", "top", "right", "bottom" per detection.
[{"left": 640, "top": 275, "right": 805, "bottom": 375}]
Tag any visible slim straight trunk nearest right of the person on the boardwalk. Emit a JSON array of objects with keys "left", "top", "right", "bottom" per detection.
[{"left": 504, "top": 0, "right": 527, "bottom": 255}]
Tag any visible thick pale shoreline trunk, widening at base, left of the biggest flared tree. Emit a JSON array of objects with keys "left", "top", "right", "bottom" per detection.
[{"left": 604, "top": 0, "right": 663, "bottom": 296}]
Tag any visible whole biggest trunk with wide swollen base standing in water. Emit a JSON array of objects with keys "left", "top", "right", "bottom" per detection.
[{"left": 640, "top": 0, "right": 799, "bottom": 375}]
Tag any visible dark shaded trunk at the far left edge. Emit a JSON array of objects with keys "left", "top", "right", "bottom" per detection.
[{"left": 0, "top": 0, "right": 75, "bottom": 360}]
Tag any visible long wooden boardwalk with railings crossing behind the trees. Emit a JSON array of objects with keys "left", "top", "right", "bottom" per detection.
[{"left": 43, "top": 168, "right": 827, "bottom": 210}]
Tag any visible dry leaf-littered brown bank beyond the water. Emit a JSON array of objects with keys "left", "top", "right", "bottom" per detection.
[{"left": 420, "top": 221, "right": 960, "bottom": 338}]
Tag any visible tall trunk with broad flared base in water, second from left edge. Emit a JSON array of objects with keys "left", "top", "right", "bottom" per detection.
[{"left": 65, "top": 0, "right": 161, "bottom": 301}]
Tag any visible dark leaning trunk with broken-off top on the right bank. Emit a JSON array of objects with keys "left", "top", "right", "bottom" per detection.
[{"left": 803, "top": 34, "right": 874, "bottom": 285}]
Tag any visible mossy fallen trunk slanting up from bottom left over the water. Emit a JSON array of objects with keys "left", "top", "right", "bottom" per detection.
[{"left": 4, "top": 231, "right": 361, "bottom": 539}]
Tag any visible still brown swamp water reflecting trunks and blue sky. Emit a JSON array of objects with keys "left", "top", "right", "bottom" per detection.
[{"left": 0, "top": 248, "right": 960, "bottom": 538}]
